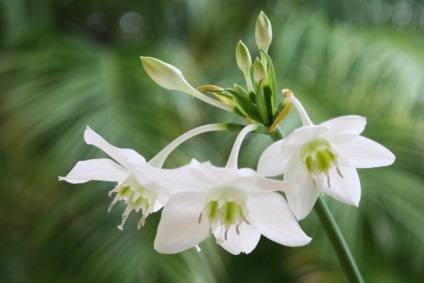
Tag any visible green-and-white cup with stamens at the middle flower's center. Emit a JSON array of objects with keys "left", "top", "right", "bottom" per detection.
[{"left": 199, "top": 187, "right": 249, "bottom": 242}]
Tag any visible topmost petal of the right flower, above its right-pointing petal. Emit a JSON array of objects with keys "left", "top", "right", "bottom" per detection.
[{"left": 318, "top": 115, "right": 367, "bottom": 135}]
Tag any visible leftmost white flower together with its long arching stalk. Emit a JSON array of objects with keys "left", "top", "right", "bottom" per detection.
[{"left": 59, "top": 124, "right": 238, "bottom": 230}]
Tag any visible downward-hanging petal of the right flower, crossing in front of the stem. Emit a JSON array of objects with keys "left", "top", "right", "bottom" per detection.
[{"left": 284, "top": 157, "right": 322, "bottom": 220}]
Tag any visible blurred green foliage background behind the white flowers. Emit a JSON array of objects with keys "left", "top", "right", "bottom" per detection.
[{"left": 0, "top": 0, "right": 424, "bottom": 283}]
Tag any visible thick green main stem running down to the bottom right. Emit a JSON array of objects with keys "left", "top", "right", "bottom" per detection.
[{"left": 271, "top": 128, "right": 364, "bottom": 283}]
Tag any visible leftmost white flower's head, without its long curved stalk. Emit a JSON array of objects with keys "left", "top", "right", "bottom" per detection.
[{"left": 59, "top": 127, "right": 166, "bottom": 230}]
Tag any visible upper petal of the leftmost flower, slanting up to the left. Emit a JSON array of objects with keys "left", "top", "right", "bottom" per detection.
[{"left": 84, "top": 127, "right": 146, "bottom": 168}]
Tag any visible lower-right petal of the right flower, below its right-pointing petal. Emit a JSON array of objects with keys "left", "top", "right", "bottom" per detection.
[{"left": 324, "top": 167, "right": 361, "bottom": 206}]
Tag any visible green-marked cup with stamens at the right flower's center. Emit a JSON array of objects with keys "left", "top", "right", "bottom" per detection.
[{"left": 301, "top": 138, "right": 343, "bottom": 187}]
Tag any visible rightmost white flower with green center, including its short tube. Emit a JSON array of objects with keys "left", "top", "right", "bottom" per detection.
[{"left": 258, "top": 90, "right": 395, "bottom": 220}]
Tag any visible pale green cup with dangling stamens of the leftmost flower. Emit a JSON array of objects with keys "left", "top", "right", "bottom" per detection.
[{"left": 108, "top": 175, "right": 157, "bottom": 230}]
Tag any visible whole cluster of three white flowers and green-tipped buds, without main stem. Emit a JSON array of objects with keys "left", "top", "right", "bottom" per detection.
[{"left": 59, "top": 12, "right": 395, "bottom": 254}]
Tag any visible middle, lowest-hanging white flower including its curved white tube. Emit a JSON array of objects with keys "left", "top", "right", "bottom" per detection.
[{"left": 151, "top": 125, "right": 311, "bottom": 254}]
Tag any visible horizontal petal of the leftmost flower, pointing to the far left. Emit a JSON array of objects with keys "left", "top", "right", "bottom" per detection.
[{"left": 59, "top": 158, "right": 129, "bottom": 184}]
